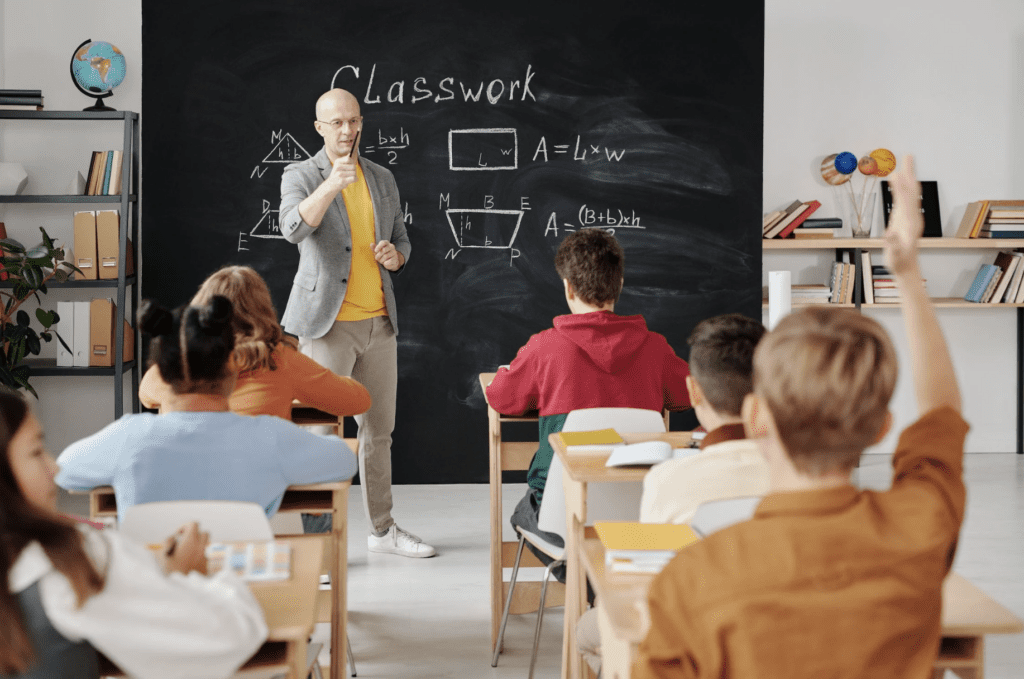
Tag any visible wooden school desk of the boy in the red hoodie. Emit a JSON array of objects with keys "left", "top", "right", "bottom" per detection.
[{"left": 480, "top": 373, "right": 565, "bottom": 648}]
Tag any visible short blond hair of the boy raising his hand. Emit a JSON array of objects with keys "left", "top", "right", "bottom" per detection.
[{"left": 754, "top": 307, "right": 898, "bottom": 476}]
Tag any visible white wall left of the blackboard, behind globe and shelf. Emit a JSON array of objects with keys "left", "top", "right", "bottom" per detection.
[{"left": 0, "top": 0, "right": 142, "bottom": 453}]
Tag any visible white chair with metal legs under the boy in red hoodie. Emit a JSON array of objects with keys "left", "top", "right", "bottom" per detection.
[{"left": 490, "top": 408, "right": 666, "bottom": 679}]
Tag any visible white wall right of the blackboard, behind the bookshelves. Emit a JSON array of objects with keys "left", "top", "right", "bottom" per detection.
[{"left": 764, "top": 0, "right": 1024, "bottom": 452}]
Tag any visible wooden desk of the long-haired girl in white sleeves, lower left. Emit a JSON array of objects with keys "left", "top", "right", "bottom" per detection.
[{"left": 100, "top": 536, "right": 324, "bottom": 679}]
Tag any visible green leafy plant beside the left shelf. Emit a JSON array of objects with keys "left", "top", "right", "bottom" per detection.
[{"left": 0, "top": 226, "right": 81, "bottom": 398}]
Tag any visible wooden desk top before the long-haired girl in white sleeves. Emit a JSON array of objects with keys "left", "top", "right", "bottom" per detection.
[{"left": 249, "top": 536, "right": 325, "bottom": 641}]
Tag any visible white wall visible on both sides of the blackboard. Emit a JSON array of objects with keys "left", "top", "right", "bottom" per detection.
[{"left": 0, "top": 0, "right": 1024, "bottom": 452}]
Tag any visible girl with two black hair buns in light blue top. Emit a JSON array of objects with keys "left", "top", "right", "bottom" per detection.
[{"left": 56, "top": 295, "right": 355, "bottom": 518}]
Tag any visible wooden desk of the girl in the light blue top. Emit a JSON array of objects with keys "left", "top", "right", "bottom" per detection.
[{"left": 81, "top": 480, "right": 352, "bottom": 679}]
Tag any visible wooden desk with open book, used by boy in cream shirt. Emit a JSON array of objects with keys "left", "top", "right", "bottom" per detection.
[{"left": 548, "top": 431, "right": 690, "bottom": 679}]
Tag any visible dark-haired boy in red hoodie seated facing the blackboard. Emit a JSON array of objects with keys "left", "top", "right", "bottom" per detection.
[{"left": 487, "top": 228, "right": 690, "bottom": 579}]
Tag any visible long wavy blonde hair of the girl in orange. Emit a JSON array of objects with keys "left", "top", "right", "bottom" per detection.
[{"left": 191, "top": 266, "right": 298, "bottom": 373}]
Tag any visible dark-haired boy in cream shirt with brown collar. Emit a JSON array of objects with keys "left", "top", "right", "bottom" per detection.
[{"left": 577, "top": 313, "right": 768, "bottom": 674}]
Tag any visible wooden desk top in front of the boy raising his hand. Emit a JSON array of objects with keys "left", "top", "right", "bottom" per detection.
[{"left": 581, "top": 538, "right": 1024, "bottom": 643}]
